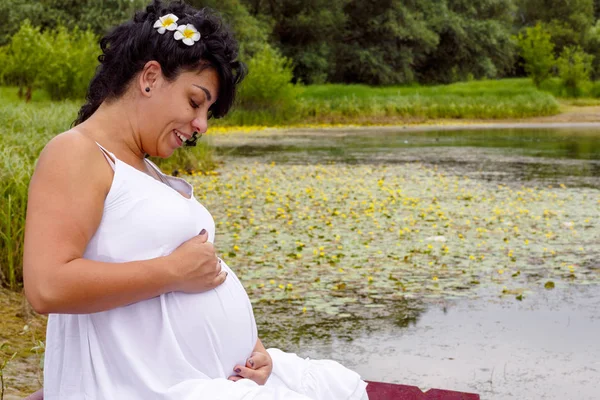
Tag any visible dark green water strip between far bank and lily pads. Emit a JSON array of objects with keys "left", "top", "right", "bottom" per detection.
[{"left": 213, "top": 129, "right": 600, "bottom": 188}]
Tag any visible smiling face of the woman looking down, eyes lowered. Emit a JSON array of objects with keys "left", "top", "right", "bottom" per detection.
[{"left": 140, "top": 68, "right": 219, "bottom": 158}]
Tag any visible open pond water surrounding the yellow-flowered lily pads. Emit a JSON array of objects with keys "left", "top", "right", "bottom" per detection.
[{"left": 210, "top": 128, "right": 600, "bottom": 400}]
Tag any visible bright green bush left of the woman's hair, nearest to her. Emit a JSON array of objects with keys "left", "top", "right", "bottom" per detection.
[{"left": 38, "top": 26, "right": 100, "bottom": 99}]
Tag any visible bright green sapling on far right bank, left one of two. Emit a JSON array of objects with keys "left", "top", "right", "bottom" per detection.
[{"left": 517, "top": 24, "right": 554, "bottom": 87}]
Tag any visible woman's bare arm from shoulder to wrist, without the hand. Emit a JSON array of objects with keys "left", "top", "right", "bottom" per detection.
[{"left": 23, "top": 132, "right": 179, "bottom": 314}]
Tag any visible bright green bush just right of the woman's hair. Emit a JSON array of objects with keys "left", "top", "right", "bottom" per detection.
[{"left": 239, "top": 47, "right": 295, "bottom": 112}]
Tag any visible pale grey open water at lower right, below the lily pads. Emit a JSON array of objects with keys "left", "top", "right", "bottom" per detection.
[{"left": 288, "top": 286, "right": 600, "bottom": 400}]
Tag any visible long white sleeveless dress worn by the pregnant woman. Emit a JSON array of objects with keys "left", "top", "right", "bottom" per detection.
[{"left": 44, "top": 144, "right": 366, "bottom": 400}]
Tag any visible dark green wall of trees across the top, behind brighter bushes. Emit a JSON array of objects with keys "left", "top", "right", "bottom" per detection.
[{"left": 0, "top": 0, "right": 600, "bottom": 87}]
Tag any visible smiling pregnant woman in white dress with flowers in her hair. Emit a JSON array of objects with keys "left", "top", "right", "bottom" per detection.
[{"left": 24, "top": 1, "right": 367, "bottom": 400}]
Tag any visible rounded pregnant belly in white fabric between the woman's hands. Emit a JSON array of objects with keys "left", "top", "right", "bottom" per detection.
[{"left": 165, "top": 263, "right": 257, "bottom": 378}]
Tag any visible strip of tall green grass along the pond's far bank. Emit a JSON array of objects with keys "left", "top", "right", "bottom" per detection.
[{"left": 300, "top": 79, "right": 559, "bottom": 120}]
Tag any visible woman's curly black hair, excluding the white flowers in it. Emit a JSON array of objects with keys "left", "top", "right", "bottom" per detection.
[{"left": 73, "top": 0, "right": 246, "bottom": 125}]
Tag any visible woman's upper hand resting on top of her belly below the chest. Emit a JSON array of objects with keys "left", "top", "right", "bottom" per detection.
[{"left": 167, "top": 229, "right": 227, "bottom": 293}]
